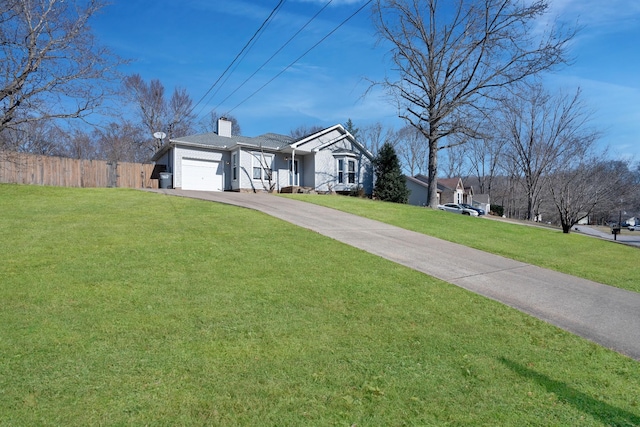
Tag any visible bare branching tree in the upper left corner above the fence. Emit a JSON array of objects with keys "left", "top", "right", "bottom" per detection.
[{"left": 0, "top": 0, "right": 123, "bottom": 139}]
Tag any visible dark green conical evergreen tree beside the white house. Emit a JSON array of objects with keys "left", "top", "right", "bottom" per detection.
[{"left": 373, "top": 142, "right": 409, "bottom": 203}]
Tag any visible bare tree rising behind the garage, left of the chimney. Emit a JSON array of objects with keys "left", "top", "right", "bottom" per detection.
[{"left": 123, "top": 74, "right": 195, "bottom": 151}]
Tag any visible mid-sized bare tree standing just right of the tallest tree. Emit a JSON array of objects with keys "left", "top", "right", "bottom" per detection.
[{"left": 500, "top": 85, "right": 598, "bottom": 220}]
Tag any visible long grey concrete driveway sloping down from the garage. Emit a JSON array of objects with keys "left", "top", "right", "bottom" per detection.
[{"left": 146, "top": 190, "right": 640, "bottom": 360}]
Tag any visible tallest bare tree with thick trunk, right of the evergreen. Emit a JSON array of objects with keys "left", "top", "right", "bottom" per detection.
[{"left": 374, "top": 0, "right": 574, "bottom": 208}]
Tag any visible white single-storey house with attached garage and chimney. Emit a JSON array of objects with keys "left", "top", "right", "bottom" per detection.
[{"left": 152, "top": 119, "right": 373, "bottom": 194}]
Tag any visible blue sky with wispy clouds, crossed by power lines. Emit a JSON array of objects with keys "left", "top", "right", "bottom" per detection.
[{"left": 93, "top": 0, "right": 640, "bottom": 157}]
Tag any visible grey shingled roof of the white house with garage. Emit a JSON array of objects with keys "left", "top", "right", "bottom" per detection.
[{"left": 151, "top": 124, "right": 373, "bottom": 161}]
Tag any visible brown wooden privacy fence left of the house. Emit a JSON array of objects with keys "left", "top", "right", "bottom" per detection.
[{"left": 0, "top": 152, "right": 158, "bottom": 188}]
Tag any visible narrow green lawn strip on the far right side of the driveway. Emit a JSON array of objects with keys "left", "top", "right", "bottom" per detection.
[{"left": 283, "top": 194, "right": 640, "bottom": 292}]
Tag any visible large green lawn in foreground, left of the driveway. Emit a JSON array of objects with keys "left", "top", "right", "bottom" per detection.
[{"left": 0, "top": 185, "right": 640, "bottom": 426}]
